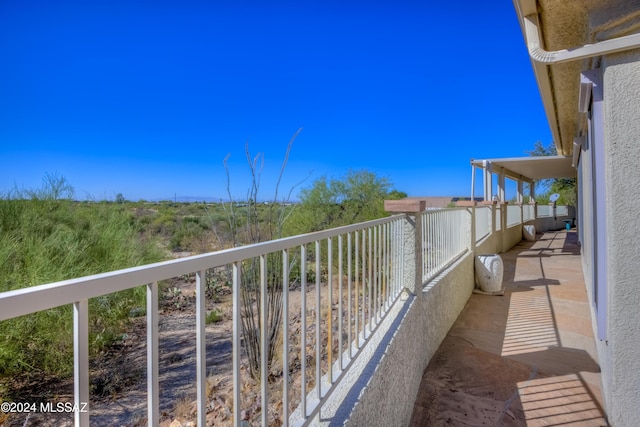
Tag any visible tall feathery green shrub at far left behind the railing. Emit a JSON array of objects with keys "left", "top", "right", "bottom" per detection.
[{"left": 0, "top": 193, "right": 161, "bottom": 377}]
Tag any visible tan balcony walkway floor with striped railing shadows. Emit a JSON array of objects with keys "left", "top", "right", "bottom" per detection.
[{"left": 410, "top": 231, "right": 607, "bottom": 426}]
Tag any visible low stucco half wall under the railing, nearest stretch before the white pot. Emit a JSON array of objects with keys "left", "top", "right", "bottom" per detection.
[{"left": 340, "top": 253, "right": 474, "bottom": 426}]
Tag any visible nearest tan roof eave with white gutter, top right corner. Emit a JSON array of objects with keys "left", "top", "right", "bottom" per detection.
[{"left": 513, "top": 0, "right": 640, "bottom": 156}]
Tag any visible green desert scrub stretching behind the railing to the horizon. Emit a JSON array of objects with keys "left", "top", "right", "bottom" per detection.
[{"left": 0, "top": 158, "right": 405, "bottom": 427}]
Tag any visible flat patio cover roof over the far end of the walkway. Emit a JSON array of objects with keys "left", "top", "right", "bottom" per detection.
[{"left": 471, "top": 156, "right": 576, "bottom": 181}]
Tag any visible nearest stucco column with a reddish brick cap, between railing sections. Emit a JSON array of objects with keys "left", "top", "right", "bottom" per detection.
[{"left": 384, "top": 199, "right": 426, "bottom": 296}]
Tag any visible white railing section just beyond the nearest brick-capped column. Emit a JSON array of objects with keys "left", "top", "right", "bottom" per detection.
[{"left": 421, "top": 208, "right": 471, "bottom": 282}]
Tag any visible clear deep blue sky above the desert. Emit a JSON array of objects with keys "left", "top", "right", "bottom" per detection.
[{"left": 0, "top": 0, "right": 551, "bottom": 200}]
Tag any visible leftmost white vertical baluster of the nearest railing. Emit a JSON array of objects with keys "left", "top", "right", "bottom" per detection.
[{"left": 73, "top": 300, "right": 89, "bottom": 427}]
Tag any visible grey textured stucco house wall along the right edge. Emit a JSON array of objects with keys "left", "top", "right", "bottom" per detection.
[{"left": 600, "top": 50, "right": 640, "bottom": 426}]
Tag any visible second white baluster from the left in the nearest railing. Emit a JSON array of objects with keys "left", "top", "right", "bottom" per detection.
[{"left": 147, "top": 282, "right": 160, "bottom": 427}]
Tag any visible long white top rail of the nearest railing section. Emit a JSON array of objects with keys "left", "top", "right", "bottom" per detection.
[{"left": 0, "top": 214, "right": 406, "bottom": 321}]
